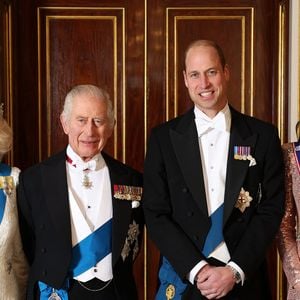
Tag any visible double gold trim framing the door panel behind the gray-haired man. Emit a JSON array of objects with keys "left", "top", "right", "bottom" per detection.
[{"left": 37, "top": 7, "right": 126, "bottom": 162}]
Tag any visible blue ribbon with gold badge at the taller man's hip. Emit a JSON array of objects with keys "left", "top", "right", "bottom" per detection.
[{"left": 155, "top": 257, "right": 187, "bottom": 300}]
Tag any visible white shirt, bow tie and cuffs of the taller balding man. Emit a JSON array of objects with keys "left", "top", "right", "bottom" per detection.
[{"left": 188, "top": 104, "right": 244, "bottom": 283}]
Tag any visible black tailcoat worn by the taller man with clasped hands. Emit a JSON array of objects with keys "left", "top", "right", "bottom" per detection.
[{"left": 143, "top": 108, "right": 284, "bottom": 300}]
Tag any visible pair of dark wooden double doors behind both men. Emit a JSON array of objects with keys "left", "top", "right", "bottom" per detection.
[{"left": 0, "top": 0, "right": 288, "bottom": 300}]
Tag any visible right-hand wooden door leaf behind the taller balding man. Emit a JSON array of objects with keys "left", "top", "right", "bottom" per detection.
[{"left": 146, "top": 0, "right": 287, "bottom": 299}]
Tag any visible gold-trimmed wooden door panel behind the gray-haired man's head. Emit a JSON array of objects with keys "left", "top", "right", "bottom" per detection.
[{"left": 38, "top": 7, "right": 125, "bottom": 156}]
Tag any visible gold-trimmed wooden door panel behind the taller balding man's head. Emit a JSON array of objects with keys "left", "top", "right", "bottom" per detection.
[{"left": 166, "top": 7, "right": 254, "bottom": 117}]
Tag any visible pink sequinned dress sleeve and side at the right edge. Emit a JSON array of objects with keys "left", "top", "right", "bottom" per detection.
[{"left": 277, "top": 143, "right": 300, "bottom": 300}]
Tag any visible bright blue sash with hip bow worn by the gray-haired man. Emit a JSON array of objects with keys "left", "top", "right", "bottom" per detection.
[{"left": 39, "top": 219, "right": 112, "bottom": 300}]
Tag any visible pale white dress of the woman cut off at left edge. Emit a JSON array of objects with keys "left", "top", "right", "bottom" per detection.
[{"left": 0, "top": 168, "right": 28, "bottom": 300}]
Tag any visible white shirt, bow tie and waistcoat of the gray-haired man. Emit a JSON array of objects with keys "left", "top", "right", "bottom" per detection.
[{"left": 66, "top": 145, "right": 112, "bottom": 282}]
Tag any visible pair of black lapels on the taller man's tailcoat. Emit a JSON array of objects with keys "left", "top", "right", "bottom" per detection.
[{"left": 170, "top": 107, "right": 257, "bottom": 224}]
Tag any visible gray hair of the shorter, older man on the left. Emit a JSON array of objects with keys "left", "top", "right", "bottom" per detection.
[{"left": 61, "top": 84, "right": 115, "bottom": 127}]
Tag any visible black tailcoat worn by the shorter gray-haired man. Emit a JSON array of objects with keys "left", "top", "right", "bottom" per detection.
[{"left": 18, "top": 151, "right": 144, "bottom": 300}]
